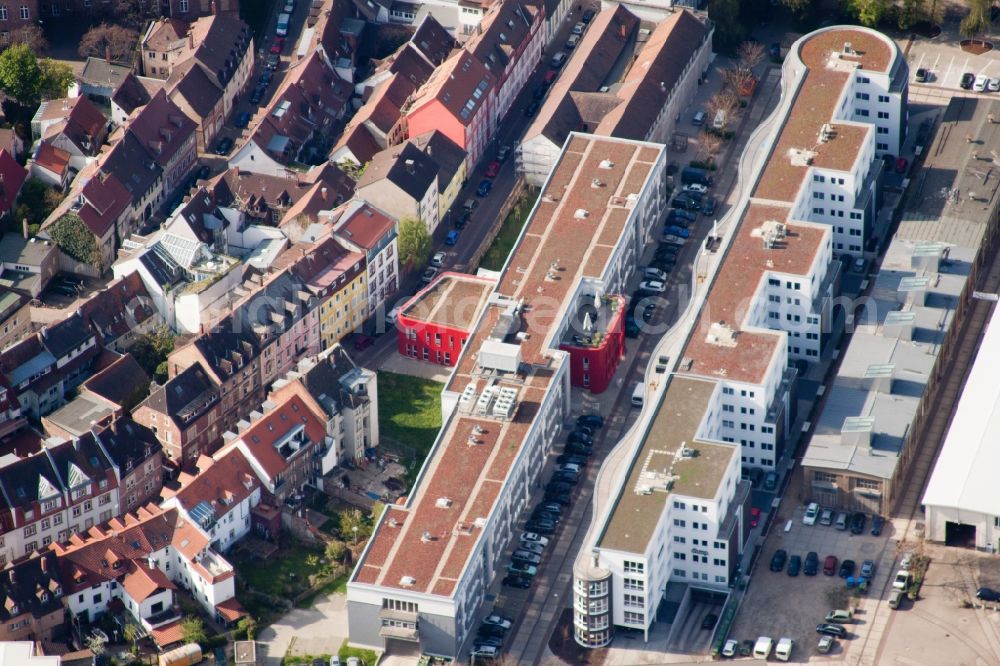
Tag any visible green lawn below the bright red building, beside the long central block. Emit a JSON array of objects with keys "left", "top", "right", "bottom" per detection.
[{"left": 378, "top": 372, "right": 444, "bottom": 454}]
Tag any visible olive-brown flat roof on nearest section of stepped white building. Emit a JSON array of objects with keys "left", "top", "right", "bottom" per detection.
[{"left": 598, "top": 375, "right": 739, "bottom": 553}]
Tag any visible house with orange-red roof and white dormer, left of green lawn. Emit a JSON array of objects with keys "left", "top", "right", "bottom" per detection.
[{"left": 216, "top": 395, "right": 328, "bottom": 506}]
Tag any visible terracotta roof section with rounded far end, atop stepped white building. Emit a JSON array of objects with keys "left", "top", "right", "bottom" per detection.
[{"left": 754, "top": 29, "right": 893, "bottom": 202}]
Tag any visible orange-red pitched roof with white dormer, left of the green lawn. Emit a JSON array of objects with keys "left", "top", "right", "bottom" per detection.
[{"left": 229, "top": 395, "right": 326, "bottom": 482}]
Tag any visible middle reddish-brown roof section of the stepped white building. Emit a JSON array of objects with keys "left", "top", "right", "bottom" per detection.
[{"left": 683, "top": 204, "right": 830, "bottom": 383}]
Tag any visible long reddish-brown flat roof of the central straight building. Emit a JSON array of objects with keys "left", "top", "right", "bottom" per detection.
[{"left": 351, "top": 134, "right": 663, "bottom": 597}]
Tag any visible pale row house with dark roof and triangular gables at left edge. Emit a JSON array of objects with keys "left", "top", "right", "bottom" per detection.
[{"left": 0, "top": 433, "right": 120, "bottom": 563}]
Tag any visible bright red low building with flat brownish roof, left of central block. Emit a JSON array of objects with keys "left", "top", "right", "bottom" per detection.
[{"left": 396, "top": 272, "right": 496, "bottom": 366}]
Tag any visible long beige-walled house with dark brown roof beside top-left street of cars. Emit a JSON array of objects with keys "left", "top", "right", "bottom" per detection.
[{"left": 166, "top": 15, "right": 254, "bottom": 152}]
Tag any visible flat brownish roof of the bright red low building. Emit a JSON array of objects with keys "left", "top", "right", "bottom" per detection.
[{"left": 400, "top": 272, "right": 496, "bottom": 332}]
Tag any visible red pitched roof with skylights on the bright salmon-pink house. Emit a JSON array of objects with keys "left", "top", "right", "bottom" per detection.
[{"left": 407, "top": 49, "right": 496, "bottom": 125}]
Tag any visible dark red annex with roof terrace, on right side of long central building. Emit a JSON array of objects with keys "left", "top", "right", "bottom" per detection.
[{"left": 559, "top": 296, "right": 625, "bottom": 393}]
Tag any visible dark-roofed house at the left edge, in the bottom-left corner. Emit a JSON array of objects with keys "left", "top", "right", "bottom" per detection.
[{"left": 0, "top": 551, "right": 66, "bottom": 643}]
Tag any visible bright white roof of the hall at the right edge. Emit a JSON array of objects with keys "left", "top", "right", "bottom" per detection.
[{"left": 921, "top": 300, "right": 1000, "bottom": 516}]
